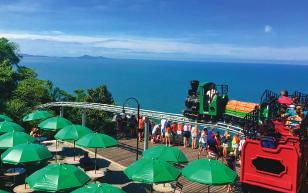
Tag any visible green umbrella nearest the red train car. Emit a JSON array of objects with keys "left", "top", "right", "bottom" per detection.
[{"left": 182, "top": 159, "right": 237, "bottom": 185}]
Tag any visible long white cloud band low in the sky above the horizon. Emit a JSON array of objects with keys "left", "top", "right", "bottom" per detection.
[{"left": 0, "top": 32, "right": 308, "bottom": 61}]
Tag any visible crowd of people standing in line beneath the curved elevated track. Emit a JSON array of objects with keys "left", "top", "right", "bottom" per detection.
[{"left": 117, "top": 115, "right": 245, "bottom": 160}]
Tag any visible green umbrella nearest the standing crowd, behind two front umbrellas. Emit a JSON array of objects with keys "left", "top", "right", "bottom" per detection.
[{"left": 143, "top": 145, "right": 188, "bottom": 163}]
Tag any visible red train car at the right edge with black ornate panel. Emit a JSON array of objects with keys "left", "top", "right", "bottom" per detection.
[{"left": 240, "top": 121, "right": 308, "bottom": 193}]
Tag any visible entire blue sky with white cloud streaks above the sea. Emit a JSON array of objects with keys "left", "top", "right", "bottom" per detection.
[{"left": 0, "top": 0, "right": 308, "bottom": 61}]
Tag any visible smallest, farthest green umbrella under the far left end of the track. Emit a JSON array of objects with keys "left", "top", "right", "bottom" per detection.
[{"left": 39, "top": 117, "right": 72, "bottom": 130}]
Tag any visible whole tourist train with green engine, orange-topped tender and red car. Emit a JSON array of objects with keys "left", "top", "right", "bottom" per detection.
[{"left": 183, "top": 80, "right": 308, "bottom": 193}]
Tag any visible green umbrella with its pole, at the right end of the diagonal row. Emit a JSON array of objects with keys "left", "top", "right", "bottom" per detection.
[{"left": 77, "top": 133, "right": 118, "bottom": 173}]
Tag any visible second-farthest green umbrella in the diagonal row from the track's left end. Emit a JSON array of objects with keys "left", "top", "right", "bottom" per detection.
[{"left": 55, "top": 125, "right": 92, "bottom": 141}]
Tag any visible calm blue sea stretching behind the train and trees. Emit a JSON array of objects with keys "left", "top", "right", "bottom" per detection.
[{"left": 22, "top": 57, "right": 308, "bottom": 113}]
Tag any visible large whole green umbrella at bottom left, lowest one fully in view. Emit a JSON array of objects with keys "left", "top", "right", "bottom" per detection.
[{"left": 26, "top": 164, "right": 90, "bottom": 192}]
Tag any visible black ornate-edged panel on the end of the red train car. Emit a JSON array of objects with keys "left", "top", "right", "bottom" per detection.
[{"left": 252, "top": 157, "right": 285, "bottom": 175}]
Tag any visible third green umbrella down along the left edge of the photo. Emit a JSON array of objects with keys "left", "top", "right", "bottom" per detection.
[{"left": 0, "top": 131, "right": 36, "bottom": 149}]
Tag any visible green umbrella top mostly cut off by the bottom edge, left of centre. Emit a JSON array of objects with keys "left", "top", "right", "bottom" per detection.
[{"left": 71, "top": 183, "right": 125, "bottom": 193}]
